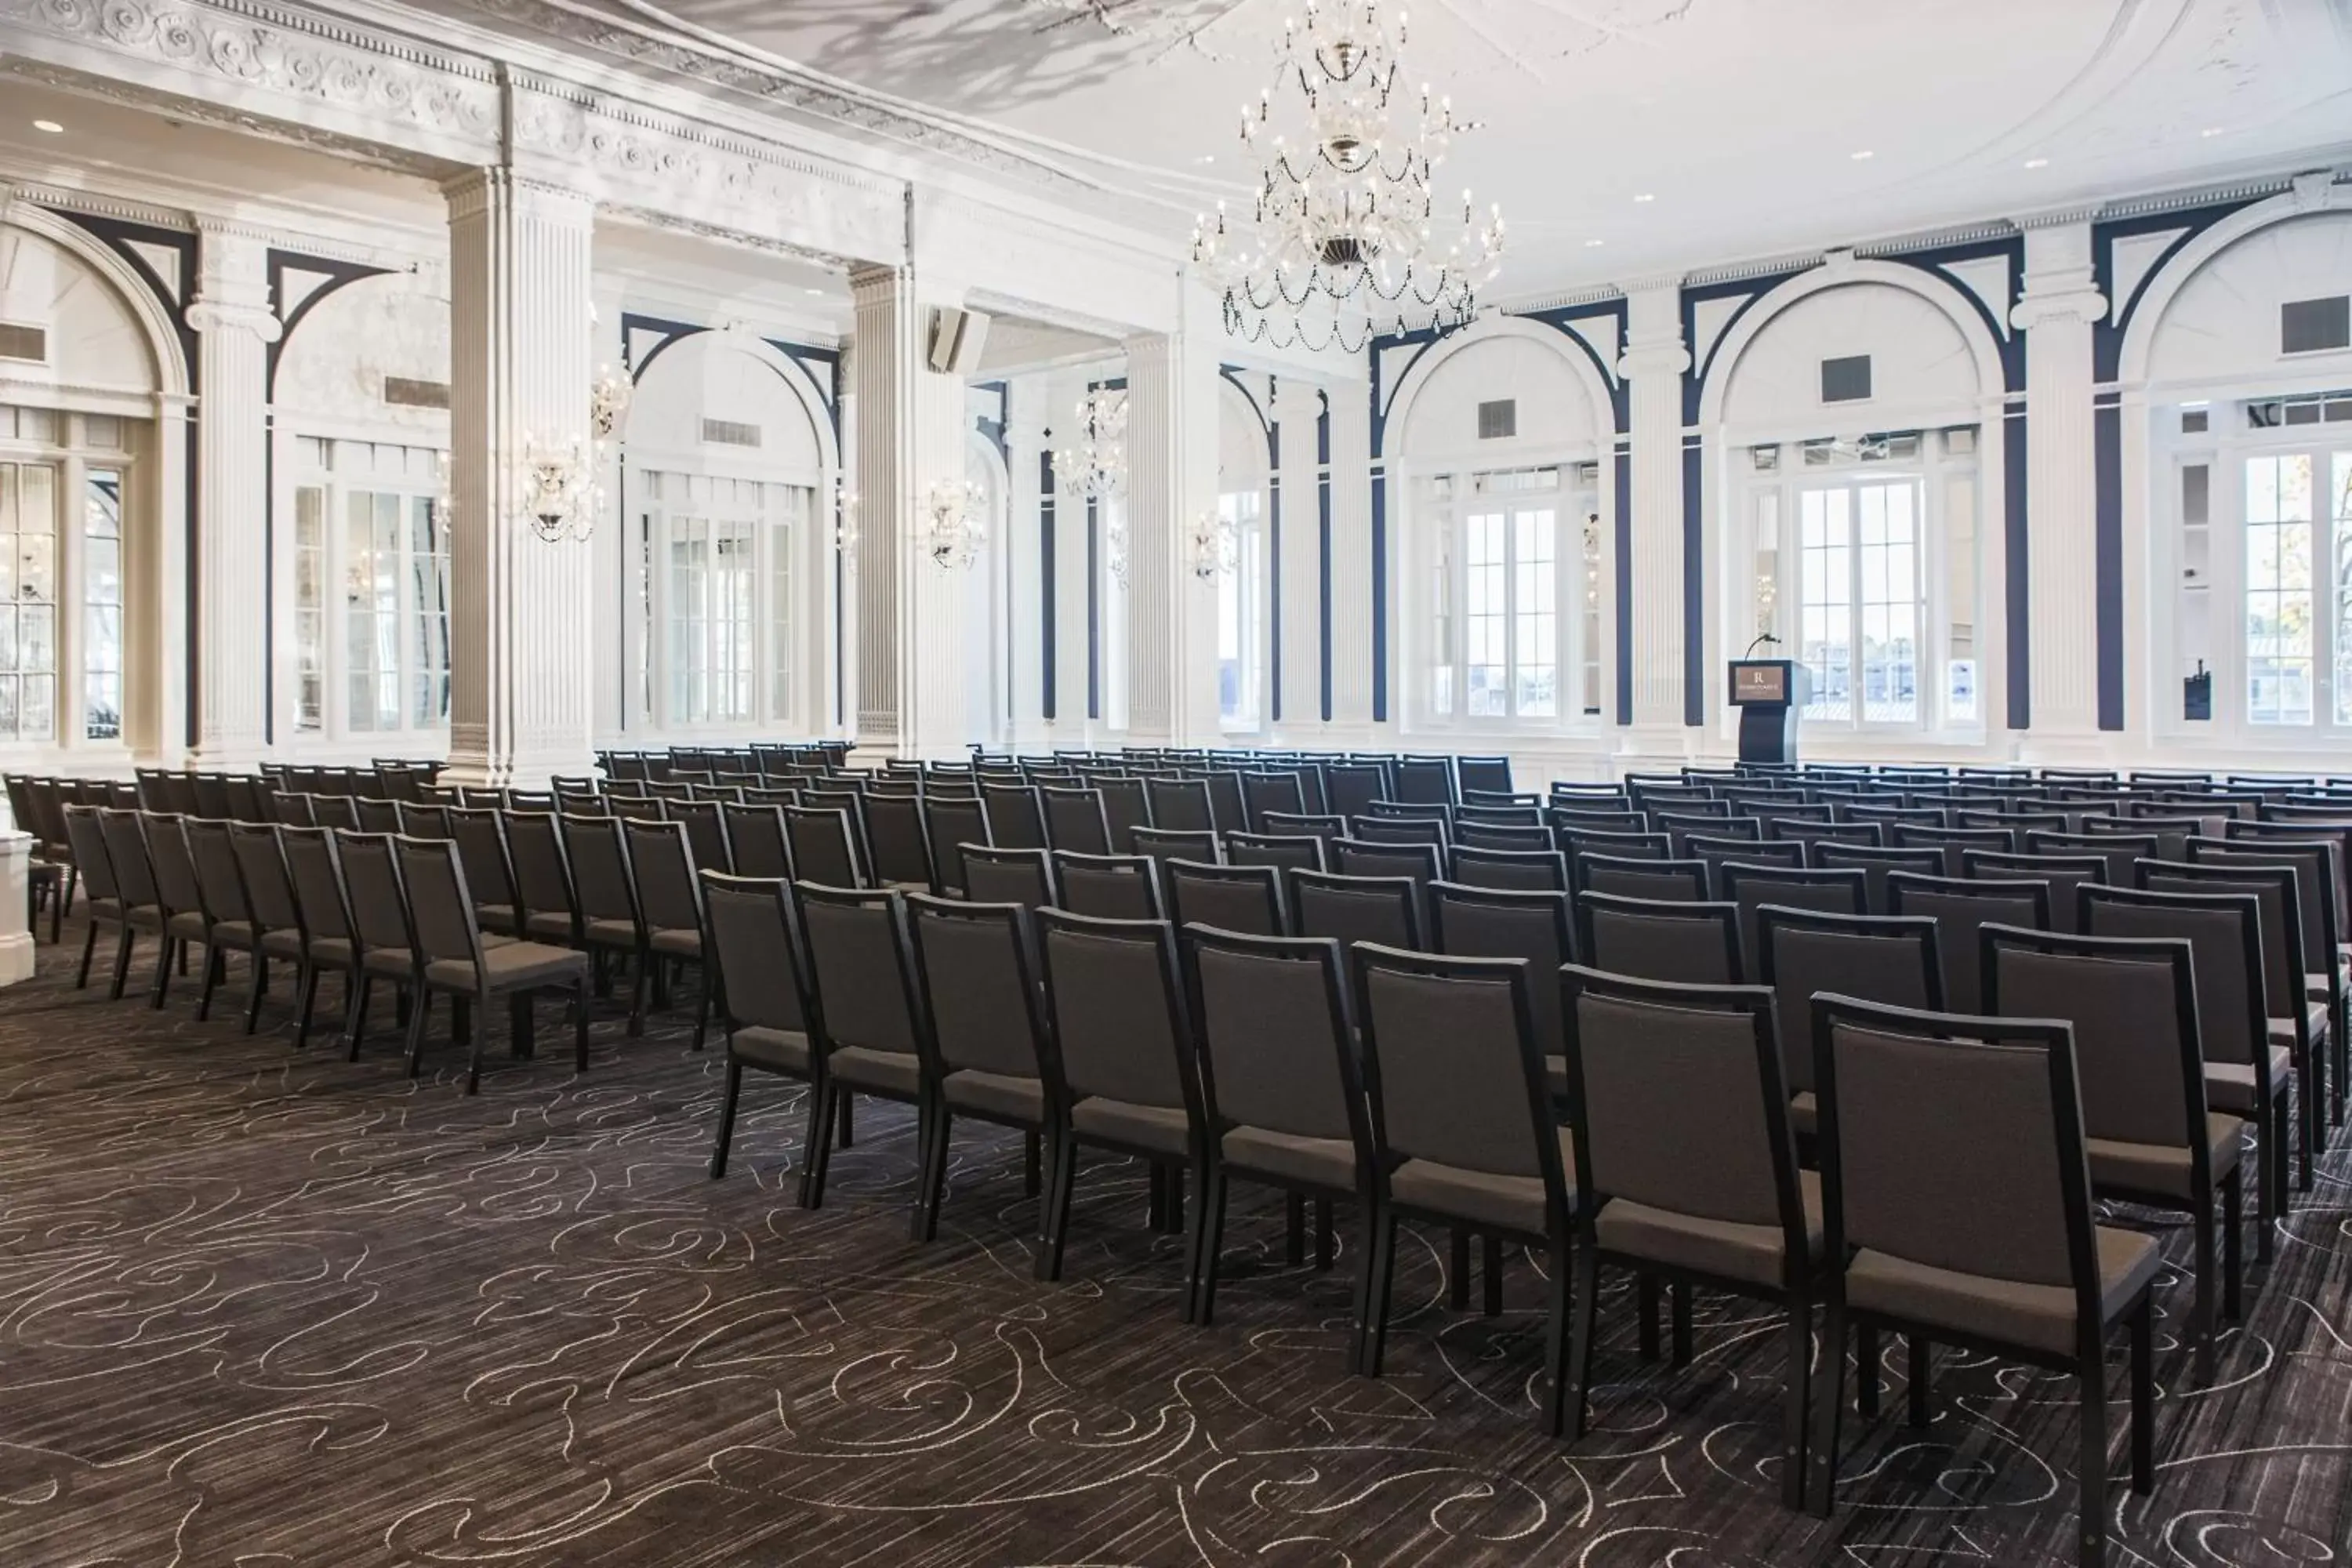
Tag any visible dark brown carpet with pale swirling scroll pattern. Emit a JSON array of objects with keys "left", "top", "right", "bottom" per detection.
[{"left": 0, "top": 926, "right": 2352, "bottom": 1568}]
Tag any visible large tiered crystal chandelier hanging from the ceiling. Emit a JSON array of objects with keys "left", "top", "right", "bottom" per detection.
[{"left": 1192, "top": 0, "right": 1503, "bottom": 353}]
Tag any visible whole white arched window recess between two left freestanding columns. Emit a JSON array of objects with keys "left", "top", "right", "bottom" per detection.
[{"left": 623, "top": 332, "right": 828, "bottom": 734}]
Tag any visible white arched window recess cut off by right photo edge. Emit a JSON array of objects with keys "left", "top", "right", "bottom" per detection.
[{"left": 2147, "top": 212, "right": 2352, "bottom": 748}]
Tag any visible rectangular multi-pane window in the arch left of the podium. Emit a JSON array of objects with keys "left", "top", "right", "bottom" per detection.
[{"left": 1421, "top": 466, "right": 1602, "bottom": 724}]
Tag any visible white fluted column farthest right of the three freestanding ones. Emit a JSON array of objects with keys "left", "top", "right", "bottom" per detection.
[{"left": 1127, "top": 287, "right": 1223, "bottom": 746}]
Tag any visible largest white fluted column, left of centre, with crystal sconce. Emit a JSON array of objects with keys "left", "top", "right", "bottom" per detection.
[{"left": 442, "top": 169, "right": 593, "bottom": 787}]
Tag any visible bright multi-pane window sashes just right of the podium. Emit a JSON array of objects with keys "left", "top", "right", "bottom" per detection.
[{"left": 1797, "top": 480, "right": 1924, "bottom": 724}]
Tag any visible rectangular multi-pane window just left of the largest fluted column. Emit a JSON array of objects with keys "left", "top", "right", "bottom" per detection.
[{"left": 292, "top": 437, "right": 449, "bottom": 736}]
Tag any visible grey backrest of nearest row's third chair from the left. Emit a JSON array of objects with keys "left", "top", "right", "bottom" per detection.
[{"left": 906, "top": 893, "right": 1058, "bottom": 1083}]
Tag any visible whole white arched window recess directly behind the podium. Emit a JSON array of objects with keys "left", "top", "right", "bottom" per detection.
[{"left": 1719, "top": 282, "right": 1999, "bottom": 741}]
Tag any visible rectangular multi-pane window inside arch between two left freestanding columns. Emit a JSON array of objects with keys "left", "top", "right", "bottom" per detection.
[{"left": 635, "top": 470, "right": 816, "bottom": 727}]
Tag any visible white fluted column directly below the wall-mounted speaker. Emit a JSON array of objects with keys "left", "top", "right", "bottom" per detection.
[{"left": 849, "top": 266, "right": 976, "bottom": 757}]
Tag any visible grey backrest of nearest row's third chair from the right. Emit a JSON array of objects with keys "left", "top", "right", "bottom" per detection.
[{"left": 1350, "top": 942, "right": 1569, "bottom": 1229}]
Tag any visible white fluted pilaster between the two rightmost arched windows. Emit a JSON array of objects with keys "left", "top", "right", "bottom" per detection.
[{"left": 2009, "top": 223, "right": 2107, "bottom": 748}]
